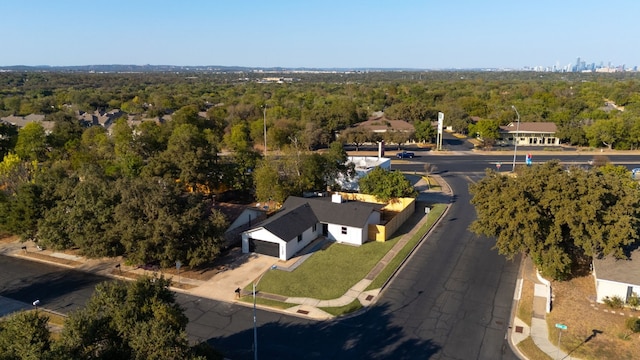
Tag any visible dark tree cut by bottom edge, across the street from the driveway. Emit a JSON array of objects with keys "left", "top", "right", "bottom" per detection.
[{"left": 56, "top": 277, "right": 205, "bottom": 359}]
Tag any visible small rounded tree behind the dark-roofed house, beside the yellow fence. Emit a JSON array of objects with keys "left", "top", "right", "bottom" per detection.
[{"left": 359, "top": 167, "right": 418, "bottom": 201}]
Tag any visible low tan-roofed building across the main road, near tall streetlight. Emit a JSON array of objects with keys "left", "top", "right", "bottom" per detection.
[{"left": 499, "top": 122, "right": 560, "bottom": 146}]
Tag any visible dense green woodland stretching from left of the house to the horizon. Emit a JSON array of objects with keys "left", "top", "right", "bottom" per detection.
[{"left": 0, "top": 72, "right": 640, "bottom": 266}]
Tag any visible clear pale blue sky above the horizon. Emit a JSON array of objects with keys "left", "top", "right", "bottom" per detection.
[{"left": 0, "top": 0, "right": 640, "bottom": 69}]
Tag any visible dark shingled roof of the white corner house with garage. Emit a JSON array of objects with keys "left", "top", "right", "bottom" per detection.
[{"left": 257, "top": 196, "right": 384, "bottom": 241}]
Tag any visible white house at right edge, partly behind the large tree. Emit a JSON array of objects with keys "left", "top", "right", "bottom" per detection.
[{"left": 593, "top": 251, "right": 640, "bottom": 302}]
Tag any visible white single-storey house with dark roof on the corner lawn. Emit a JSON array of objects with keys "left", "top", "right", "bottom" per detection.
[{"left": 242, "top": 194, "right": 384, "bottom": 260}]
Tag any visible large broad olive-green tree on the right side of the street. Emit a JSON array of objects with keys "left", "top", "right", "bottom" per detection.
[{"left": 470, "top": 161, "right": 640, "bottom": 279}]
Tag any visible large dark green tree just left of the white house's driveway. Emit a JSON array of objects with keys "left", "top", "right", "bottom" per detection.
[{"left": 112, "top": 178, "right": 227, "bottom": 266}]
